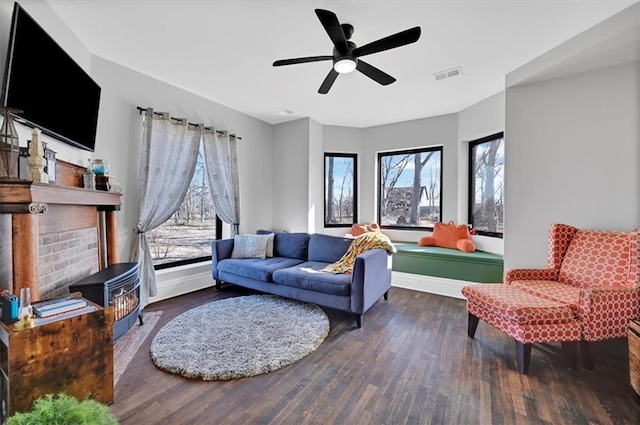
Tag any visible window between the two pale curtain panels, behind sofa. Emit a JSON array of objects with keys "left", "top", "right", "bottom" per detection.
[{"left": 147, "top": 148, "right": 222, "bottom": 270}]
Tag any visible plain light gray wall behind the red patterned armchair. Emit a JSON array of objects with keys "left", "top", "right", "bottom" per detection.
[{"left": 505, "top": 63, "right": 640, "bottom": 267}]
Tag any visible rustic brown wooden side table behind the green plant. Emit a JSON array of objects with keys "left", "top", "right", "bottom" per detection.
[{"left": 0, "top": 303, "right": 113, "bottom": 423}]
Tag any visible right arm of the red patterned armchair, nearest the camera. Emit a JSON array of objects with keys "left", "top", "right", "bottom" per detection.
[{"left": 578, "top": 283, "right": 640, "bottom": 341}]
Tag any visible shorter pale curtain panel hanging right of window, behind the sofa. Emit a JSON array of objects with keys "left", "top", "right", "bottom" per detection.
[{"left": 202, "top": 128, "right": 240, "bottom": 237}]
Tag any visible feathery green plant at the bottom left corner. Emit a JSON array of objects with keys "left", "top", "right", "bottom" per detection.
[{"left": 7, "top": 393, "right": 118, "bottom": 425}]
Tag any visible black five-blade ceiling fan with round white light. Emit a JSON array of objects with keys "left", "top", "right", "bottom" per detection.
[{"left": 273, "top": 9, "right": 420, "bottom": 94}]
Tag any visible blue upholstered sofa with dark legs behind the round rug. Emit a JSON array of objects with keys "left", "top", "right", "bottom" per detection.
[{"left": 212, "top": 232, "right": 391, "bottom": 328}]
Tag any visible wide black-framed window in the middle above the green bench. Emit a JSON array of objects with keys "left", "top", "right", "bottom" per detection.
[{"left": 378, "top": 147, "right": 442, "bottom": 229}]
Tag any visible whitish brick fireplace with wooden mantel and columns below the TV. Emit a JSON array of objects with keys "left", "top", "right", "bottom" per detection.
[{"left": 0, "top": 161, "right": 121, "bottom": 301}]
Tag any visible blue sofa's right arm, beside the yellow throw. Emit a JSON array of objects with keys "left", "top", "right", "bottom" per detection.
[{"left": 351, "top": 248, "right": 391, "bottom": 314}]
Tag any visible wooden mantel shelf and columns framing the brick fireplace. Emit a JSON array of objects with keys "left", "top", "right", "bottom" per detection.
[{"left": 0, "top": 180, "right": 121, "bottom": 301}]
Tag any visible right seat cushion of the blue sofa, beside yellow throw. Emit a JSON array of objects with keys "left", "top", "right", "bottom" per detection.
[{"left": 273, "top": 261, "right": 351, "bottom": 296}]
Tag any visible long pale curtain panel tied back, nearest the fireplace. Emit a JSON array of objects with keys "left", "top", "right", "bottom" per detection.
[{"left": 130, "top": 108, "right": 202, "bottom": 308}]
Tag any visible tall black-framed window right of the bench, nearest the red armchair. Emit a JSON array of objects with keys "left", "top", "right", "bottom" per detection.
[{"left": 469, "top": 133, "right": 504, "bottom": 238}]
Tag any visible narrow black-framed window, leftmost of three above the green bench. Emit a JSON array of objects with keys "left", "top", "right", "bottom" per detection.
[{"left": 324, "top": 153, "right": 358, "bottom": 227}]
